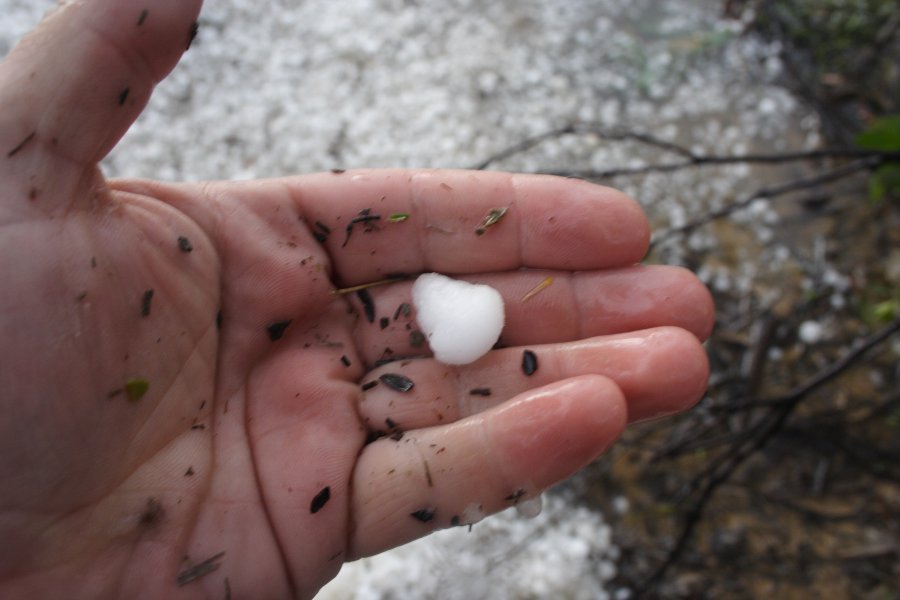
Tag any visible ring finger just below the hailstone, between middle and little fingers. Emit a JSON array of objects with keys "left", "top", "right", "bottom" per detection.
[{"left": 360, "top": 327, "right": 709, "bottom": 434}]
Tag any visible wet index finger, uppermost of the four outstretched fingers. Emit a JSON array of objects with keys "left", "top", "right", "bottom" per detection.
[{"left": 284, "top": 170, "right": 649, "bottom": 285}]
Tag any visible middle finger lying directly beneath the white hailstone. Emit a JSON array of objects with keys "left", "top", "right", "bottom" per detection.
[{"left": 347, "top": 265, "right": 714, "bottom": 365}]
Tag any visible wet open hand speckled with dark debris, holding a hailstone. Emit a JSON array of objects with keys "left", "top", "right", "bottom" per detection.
[{"left": 0, "top": 0, "right": 713, "bottom": 598}]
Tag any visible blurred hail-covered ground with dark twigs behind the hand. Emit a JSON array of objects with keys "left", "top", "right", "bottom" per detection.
[{"left": 0, "top": 0, "right": 900, "bottom": 600}]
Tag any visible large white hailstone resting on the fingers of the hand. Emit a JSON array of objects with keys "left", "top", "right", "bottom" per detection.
[{"left": 412, "top": 273, "right": 504, "bottom": 365}]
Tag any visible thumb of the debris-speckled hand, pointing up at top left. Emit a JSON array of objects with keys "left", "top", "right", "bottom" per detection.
[{"left": 0, "top": 0, "right": 201, "bottom": 200}]
